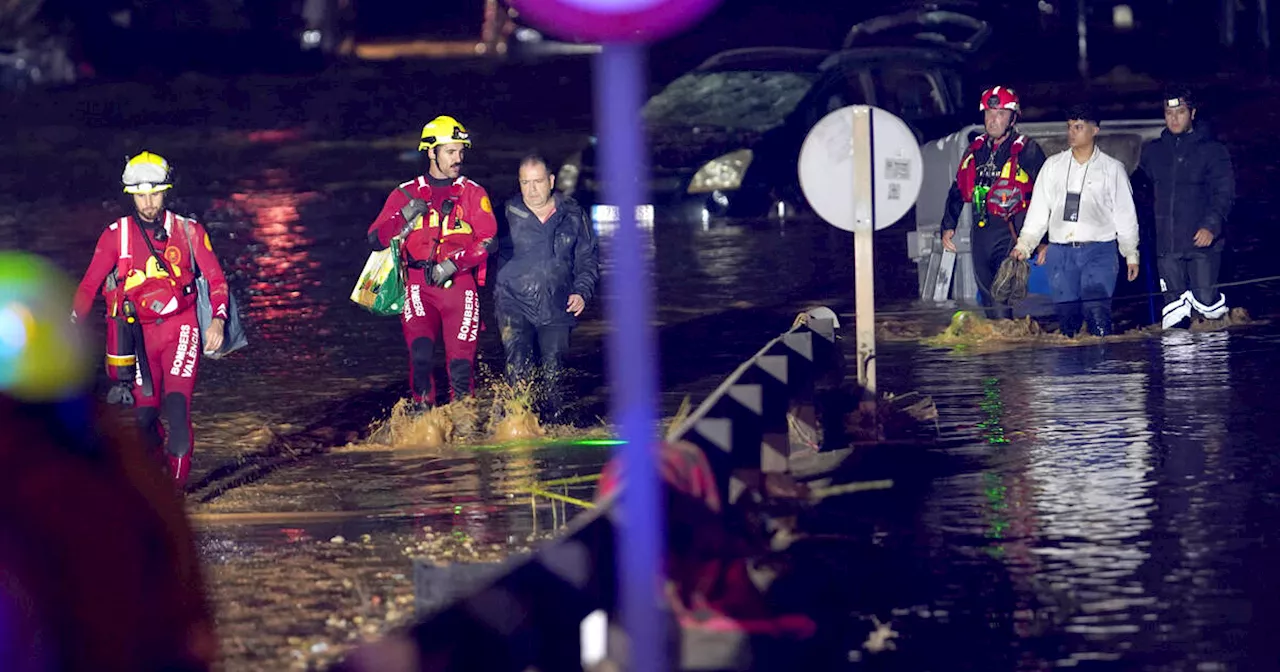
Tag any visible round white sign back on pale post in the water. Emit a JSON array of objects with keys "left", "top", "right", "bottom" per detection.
[{"left": 799, "top": 105, "right": 923, "bottom": 407}]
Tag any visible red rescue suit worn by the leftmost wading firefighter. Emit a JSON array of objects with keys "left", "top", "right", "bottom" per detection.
[{"left": 73, "top": 210, "right": 228, "bottom": 468}]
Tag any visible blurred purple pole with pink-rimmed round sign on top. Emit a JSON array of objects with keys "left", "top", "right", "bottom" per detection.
[{"left": 512, "top": 0, "right": 719, "bottom": 672}]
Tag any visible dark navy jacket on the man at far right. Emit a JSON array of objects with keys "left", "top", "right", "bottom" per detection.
[{"left": 1138, "top": 123, "right": 1235, "bottom": 255}]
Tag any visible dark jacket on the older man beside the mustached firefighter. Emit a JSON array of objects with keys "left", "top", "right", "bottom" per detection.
[{"left": 494, "top": 193, "right": 600, "bottom": 326}]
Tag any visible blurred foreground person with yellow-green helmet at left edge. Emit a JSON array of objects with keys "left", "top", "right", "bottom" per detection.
[{"left": 0, "top": 252, "right": 218, "bottom": 671}]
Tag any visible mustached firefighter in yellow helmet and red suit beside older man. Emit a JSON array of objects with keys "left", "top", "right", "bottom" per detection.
[{"left": 369, "top": 116, "right": 498, "bottom": 408}]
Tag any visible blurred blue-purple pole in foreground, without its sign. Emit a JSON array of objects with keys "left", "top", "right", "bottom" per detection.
[{"left": 594, "top": 44, "right": 667, "bottom": 672}]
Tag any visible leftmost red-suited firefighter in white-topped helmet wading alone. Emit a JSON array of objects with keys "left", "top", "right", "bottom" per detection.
[{"left": 72, "top": 152, "right": 228, "bottom": 488}]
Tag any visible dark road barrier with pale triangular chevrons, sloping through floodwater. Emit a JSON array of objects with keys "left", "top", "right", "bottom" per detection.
[{"left": 339, "top": 310, "right": 845, "bottom": 672}]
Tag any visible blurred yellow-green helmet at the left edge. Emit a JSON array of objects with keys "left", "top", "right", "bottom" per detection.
[{"left": 0, "top": 251, "right": 92, "bottom": 402}]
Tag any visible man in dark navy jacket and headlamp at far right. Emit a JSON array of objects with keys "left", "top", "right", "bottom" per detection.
[{"left": 1138, "top": 87, "right": 1235, "bottom": 329}]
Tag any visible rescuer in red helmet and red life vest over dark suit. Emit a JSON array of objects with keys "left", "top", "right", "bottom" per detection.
[{"left": 942, "top": 86, "right": 1046, "bottom": 319}]
